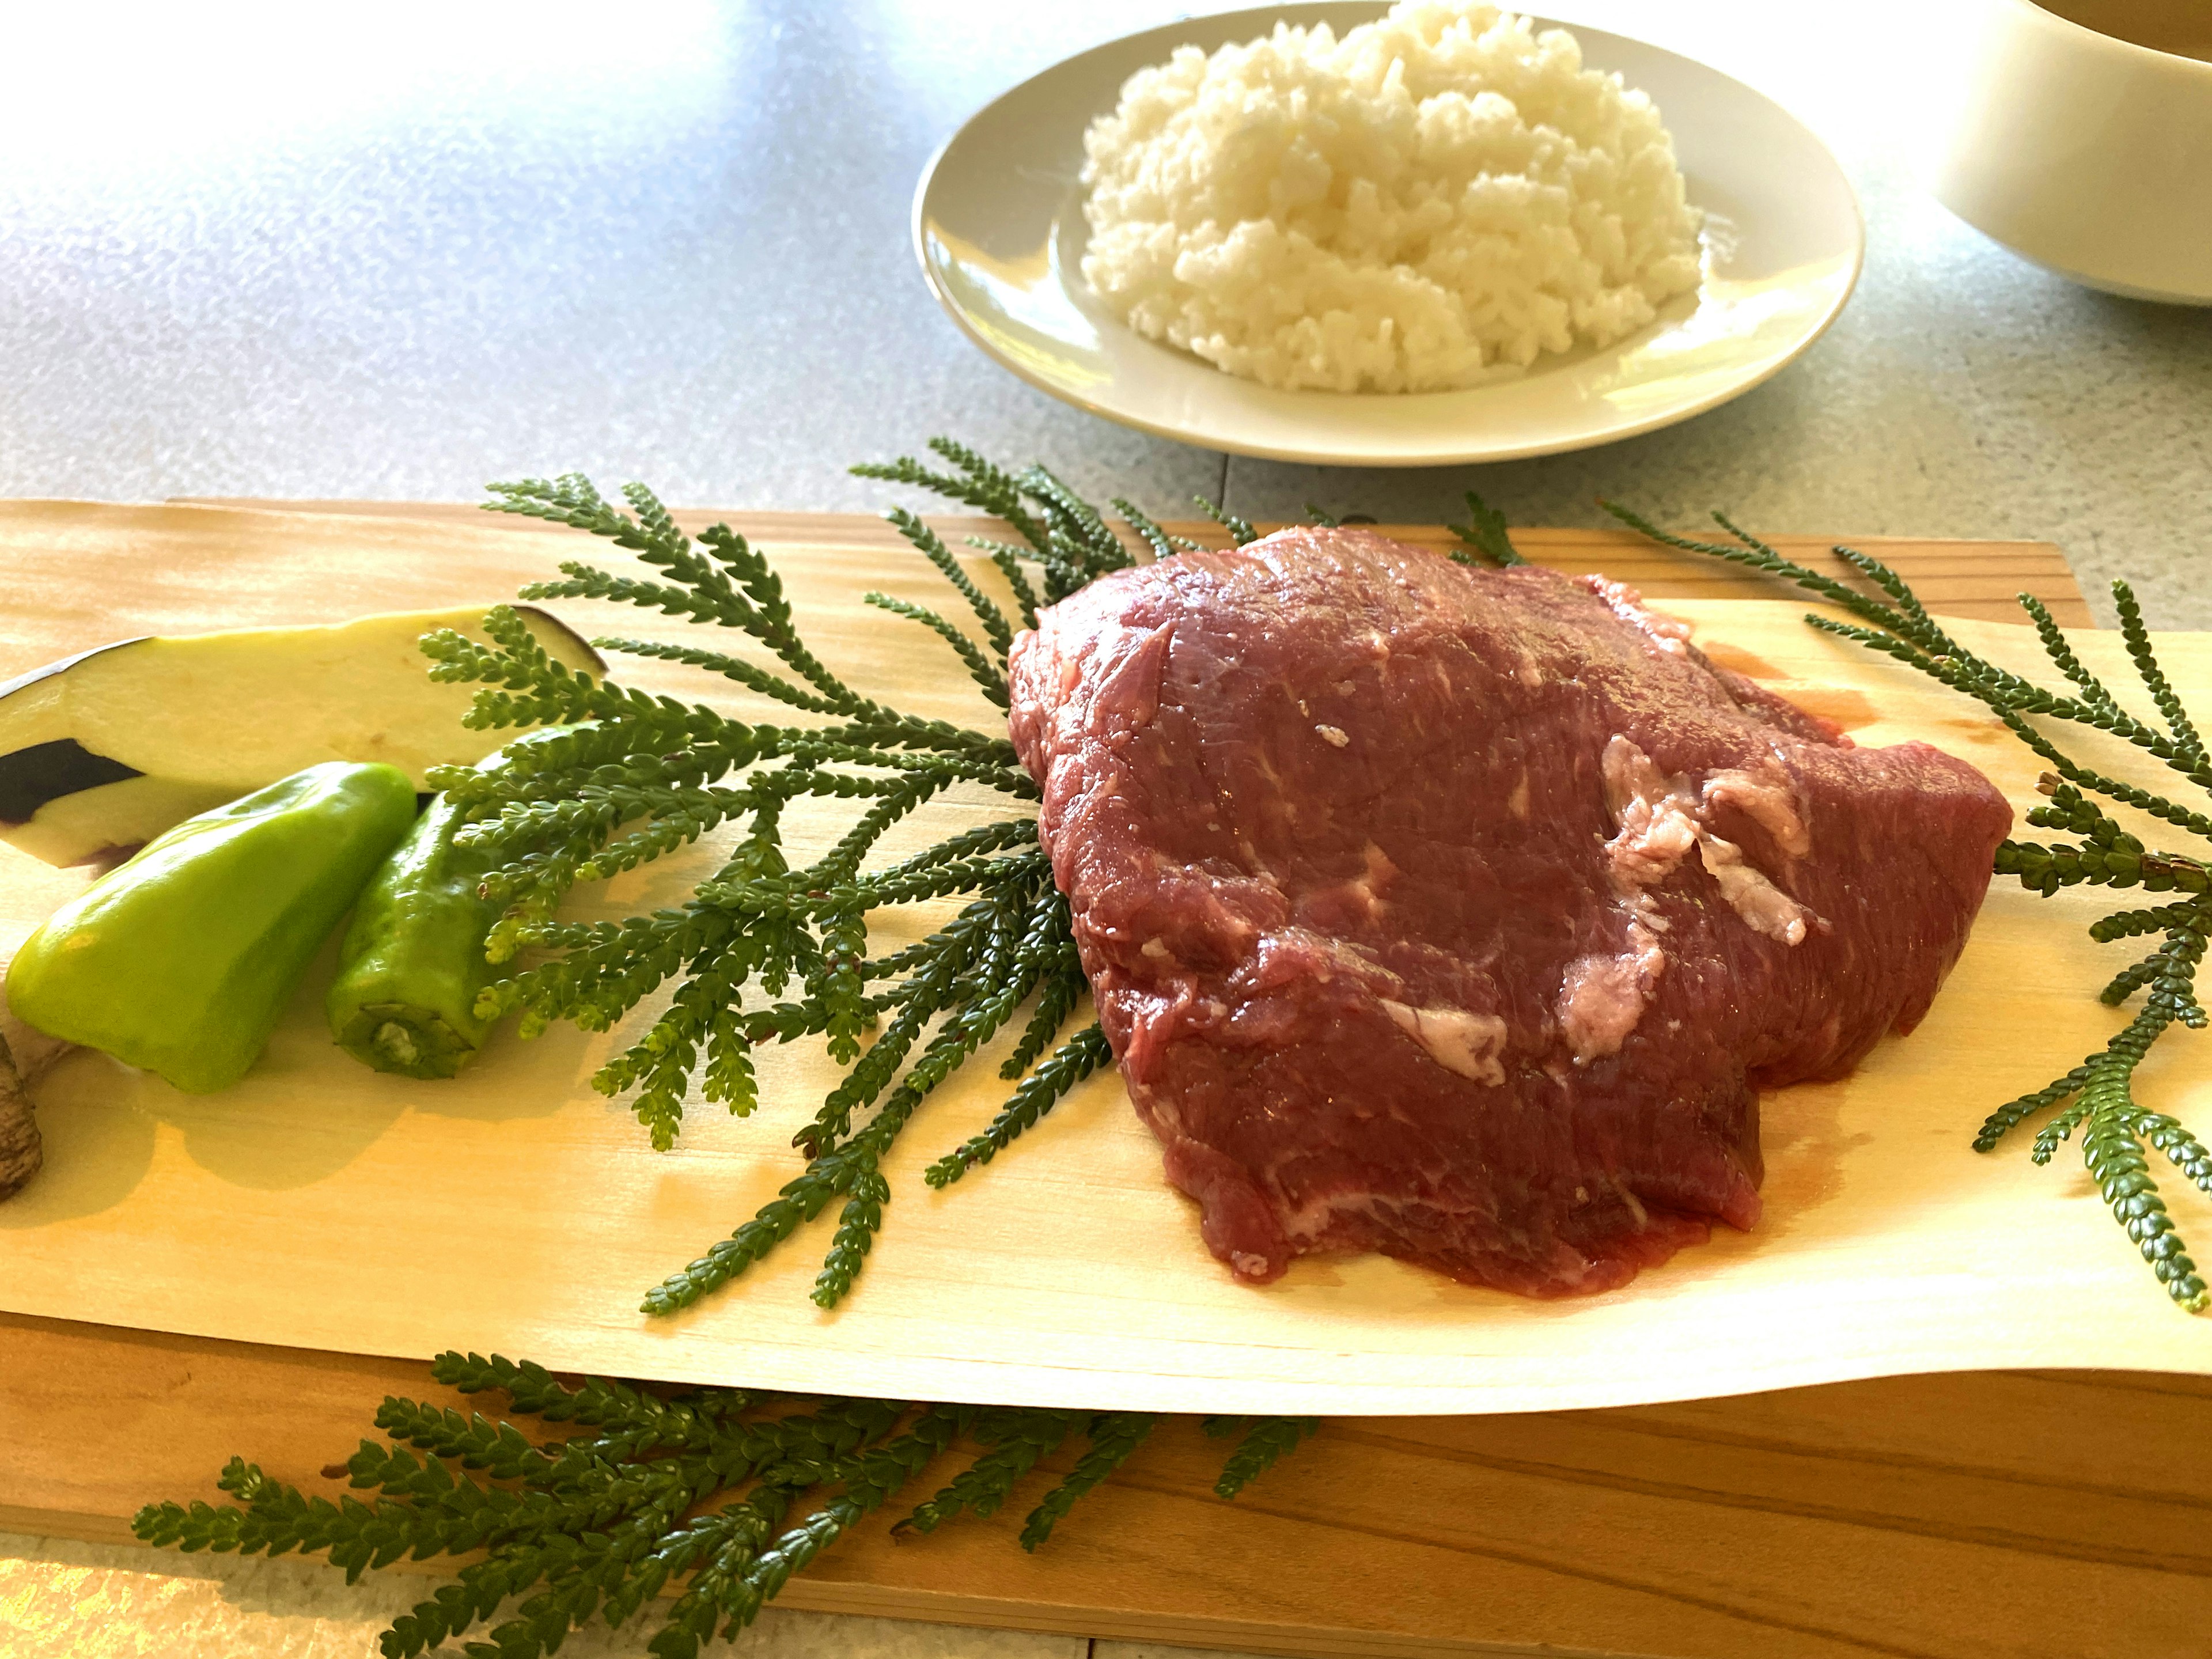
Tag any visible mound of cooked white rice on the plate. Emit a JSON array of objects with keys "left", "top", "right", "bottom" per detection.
[{"left": 1084, "top": 0, "right": 1699, "bottom": 392}]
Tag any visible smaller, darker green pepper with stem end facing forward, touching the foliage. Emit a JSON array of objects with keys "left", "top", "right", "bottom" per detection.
[{"left": 323, "top": 794, "right": 502, "bottom": 1077}]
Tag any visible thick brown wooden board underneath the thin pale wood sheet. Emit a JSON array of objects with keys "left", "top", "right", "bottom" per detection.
[{"left": 0, "top": 505, "right": 2212, "bottom": 1659}]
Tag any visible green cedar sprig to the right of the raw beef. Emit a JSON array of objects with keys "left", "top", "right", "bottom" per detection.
[{"left": 1610, "top": 502, "right": 2212, "bottom": 1312}]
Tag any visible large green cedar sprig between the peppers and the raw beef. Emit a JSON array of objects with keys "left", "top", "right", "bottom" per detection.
[{"left": 404, "top": 440, "right": 1176, "bottom": 1314}]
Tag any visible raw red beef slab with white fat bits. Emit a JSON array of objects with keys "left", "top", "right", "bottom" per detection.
[{"left": 1013, "top": 531, "right": 2011, "bottom": 1296}]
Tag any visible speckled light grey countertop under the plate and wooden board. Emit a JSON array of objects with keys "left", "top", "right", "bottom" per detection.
[{"left": 0, "top": 0, "right": 2212, "bottom": 1659}]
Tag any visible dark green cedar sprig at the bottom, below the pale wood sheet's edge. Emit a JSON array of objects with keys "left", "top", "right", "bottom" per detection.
[{"left": 131, "top": 1354, "right": 1312, "bottom": 1659}]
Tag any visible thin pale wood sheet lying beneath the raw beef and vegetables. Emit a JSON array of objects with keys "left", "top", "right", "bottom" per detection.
[{"left": 0, "top": 505, "right": 2212, "bottom": 1414}]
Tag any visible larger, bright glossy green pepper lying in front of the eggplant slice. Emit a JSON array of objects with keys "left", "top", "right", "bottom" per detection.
[{"left": 7, "top": 761, "right": 416, "bottom": 1095}]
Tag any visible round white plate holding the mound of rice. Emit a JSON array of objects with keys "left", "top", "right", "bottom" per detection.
[{"left": 914, "top": 5, "right": 1865, "bottom": 467}]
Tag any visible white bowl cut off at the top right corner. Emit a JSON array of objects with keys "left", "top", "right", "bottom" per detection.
[{"left": 1933, "top": 0, "right": 2212, "bottom": 305}]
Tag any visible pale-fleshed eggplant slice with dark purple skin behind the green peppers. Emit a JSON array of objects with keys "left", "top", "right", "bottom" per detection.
[{"left": 0, "top": 606, "right": 606, "bottom": 865}]
